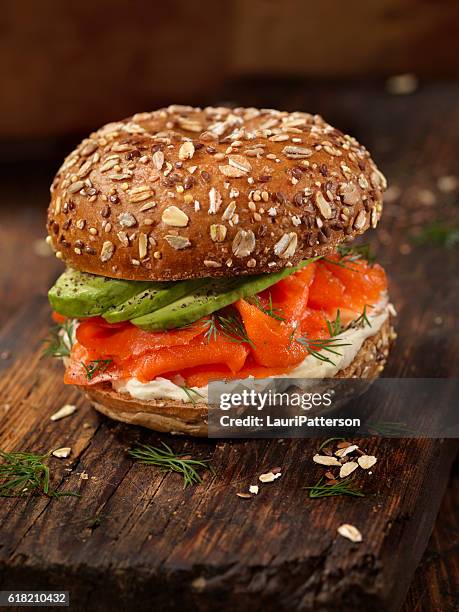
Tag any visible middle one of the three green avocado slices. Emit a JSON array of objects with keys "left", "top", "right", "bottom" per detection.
[{"left": 102, "top": 278, "right": 208, "bottom": 323}]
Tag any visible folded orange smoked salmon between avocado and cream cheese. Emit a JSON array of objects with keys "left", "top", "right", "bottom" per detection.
[{"left": 63, "top": 255, "right": 387, "bottom": 387}]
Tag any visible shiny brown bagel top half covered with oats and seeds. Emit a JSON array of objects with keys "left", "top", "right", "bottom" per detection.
[{"left": 48, "top": 106, "right": 386, "bottom": 280}]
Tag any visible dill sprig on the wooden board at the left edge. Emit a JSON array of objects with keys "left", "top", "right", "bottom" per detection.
[{"left": 0, "top": 450, "right": 79, "bottom": 497}]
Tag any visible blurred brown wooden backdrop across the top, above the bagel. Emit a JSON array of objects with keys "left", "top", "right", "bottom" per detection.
[{"left": 0, "top": 0, "right": 459, "bottom": 139}]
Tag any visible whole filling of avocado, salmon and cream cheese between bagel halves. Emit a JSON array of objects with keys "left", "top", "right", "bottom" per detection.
[{"left": 50, "top": 251, "right": 389, "bottom": 403}]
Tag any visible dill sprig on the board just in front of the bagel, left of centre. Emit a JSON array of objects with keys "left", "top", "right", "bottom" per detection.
[{"left": 129, "top": 442, "right": 212, "bottom": 489}]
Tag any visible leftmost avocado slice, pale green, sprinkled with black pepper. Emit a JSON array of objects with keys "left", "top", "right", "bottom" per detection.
[{"left": 48, "top": 268, "right": 150, "bottom": 319}]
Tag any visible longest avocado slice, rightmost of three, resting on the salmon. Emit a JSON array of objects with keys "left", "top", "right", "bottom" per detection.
[{"left": 131, "top": 257, "right": 318, "bottom": 331}]
